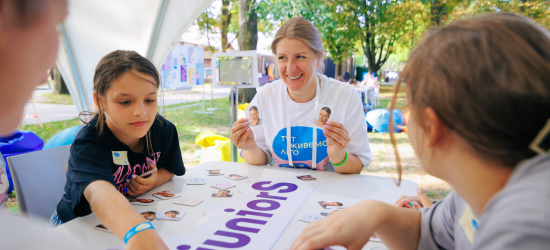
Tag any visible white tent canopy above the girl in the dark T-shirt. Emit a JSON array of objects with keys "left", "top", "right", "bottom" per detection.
[{"left": 57, "top": 0, "right": 214, "bottom": 112}]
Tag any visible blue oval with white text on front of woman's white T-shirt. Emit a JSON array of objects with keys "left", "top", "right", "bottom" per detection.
[{"left": 272, "top": 126, "right": 328, "bottom": 164}]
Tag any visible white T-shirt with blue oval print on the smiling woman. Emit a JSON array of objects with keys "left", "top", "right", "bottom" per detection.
[{"left": 250, "top": 74, "right": 371, "bottom": 170}]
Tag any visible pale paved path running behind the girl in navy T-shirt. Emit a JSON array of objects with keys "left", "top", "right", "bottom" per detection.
[{"left": 23, "top": 86, "right": 229, "bottom": 124}]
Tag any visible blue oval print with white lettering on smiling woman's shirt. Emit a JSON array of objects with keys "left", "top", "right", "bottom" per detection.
[{"left": 272, "top": 126, "right": 328, "bottom": 170}]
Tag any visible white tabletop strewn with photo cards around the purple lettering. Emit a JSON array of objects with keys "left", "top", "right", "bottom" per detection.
[{"left": 55, "top": 162, "right": 418, "bottom": 250}]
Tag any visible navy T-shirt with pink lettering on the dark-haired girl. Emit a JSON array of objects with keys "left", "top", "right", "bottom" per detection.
[{"left": 57, "top": 115, "right": 185, "bottom": 223}]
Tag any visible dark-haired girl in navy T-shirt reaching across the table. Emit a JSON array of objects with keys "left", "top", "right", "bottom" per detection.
[{"left": 50, "top": 50, "right": 185, "bottom": 248}]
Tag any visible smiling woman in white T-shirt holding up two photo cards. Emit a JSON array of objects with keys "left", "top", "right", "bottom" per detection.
[{"left": 231, "top": 17, "right": 371, "bottom": 173}]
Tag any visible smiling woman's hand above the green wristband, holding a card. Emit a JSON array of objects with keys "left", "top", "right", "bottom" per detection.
[{"left": 323, "top": 122, "right": 351, "bottom": 163}]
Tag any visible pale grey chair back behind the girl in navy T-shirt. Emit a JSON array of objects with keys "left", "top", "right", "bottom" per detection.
[{"left": 8, "top": 145, "right": 71, "bottom": 220}]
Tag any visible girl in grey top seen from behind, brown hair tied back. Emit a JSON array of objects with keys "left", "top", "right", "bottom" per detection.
[{"left": 291, "top": 13, "right": 550, "bottom": 250}]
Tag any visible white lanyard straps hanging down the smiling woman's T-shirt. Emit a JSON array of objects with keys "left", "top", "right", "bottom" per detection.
[{"left": 286, "top": 76, "right": 321, "bottom": 169}]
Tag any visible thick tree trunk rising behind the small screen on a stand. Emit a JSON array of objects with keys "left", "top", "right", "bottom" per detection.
[{"left": 239, "top": 0, "right": 258, "bottom": 103}]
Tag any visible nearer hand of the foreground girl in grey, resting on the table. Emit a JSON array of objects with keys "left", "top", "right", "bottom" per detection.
[{"left": 290, "top": 201, "right": 381, "bottom": 250}]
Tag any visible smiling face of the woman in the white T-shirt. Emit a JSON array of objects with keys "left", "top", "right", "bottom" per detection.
[{"left": 277, "top": 38, "right": 321, "bottom": 91}]
